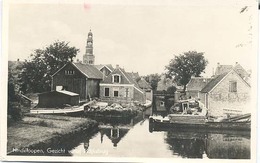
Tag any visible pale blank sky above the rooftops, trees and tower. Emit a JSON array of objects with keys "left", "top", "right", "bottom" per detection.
[{"left": 8, "top": 0, "right": 257, "bottom": 76}]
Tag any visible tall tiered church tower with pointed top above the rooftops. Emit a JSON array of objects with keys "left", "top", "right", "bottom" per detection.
[{"left": 83, "top": 30, "right": 95, "bottom": 65}]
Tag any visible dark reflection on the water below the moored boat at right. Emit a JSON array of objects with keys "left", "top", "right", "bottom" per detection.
[{"left": 166, "top": 130, "right": 250, "bottom": 159}]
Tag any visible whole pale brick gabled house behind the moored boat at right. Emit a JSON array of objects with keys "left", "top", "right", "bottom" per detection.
[{"left": 199, "top": 69, "right": 251, "bottom": 116}]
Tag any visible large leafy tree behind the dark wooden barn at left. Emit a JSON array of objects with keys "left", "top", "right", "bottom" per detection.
[{"left": 20, "top": 41, "right": 79, "bottom": 93}]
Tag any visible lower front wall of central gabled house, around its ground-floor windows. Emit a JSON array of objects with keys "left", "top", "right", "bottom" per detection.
[{"left": 100, "top": 85, "right": 134, "bottom": 103}]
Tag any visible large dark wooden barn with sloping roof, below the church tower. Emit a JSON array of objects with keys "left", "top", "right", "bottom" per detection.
[{"left": 52, "top": 62, "right": 103, "bottom": 100}]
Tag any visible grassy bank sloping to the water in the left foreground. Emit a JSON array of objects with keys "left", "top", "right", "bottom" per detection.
[{"left": 7, "top": 115, "right": 98, "bottom": 153}]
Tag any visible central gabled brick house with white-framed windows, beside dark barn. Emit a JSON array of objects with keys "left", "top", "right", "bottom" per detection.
[{"left": 100, "top": 65, "right": 145, "bottom": 103}]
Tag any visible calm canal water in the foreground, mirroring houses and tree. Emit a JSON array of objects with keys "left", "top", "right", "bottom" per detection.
[{"left": 69, "top": 107, "right": 250, "bottom": 159}]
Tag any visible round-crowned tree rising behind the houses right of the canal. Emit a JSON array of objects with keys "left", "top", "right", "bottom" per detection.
[{"left": 166, "top": 51, "right": 208, "bottom": 92}]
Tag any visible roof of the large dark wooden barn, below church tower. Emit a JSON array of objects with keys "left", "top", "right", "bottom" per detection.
[{"left": 52, "top": 62, "right": 103, "bottom": 79}]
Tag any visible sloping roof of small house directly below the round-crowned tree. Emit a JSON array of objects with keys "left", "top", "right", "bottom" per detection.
[{"left": 186, "top": 77, "right": 211, "bottom": 91}]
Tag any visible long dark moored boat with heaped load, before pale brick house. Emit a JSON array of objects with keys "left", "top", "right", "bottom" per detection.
[{"left": 149, "top": 100, "right": 251, "bottom": 130}]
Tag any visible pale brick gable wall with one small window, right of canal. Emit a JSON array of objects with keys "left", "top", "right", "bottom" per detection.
[{"left": 208, "top": 72, "right": 251, "bottom": 116}]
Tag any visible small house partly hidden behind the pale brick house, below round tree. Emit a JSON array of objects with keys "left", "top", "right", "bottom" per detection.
[{"left": 186, "top": 77, "right": 211, "bottom": 99}]
